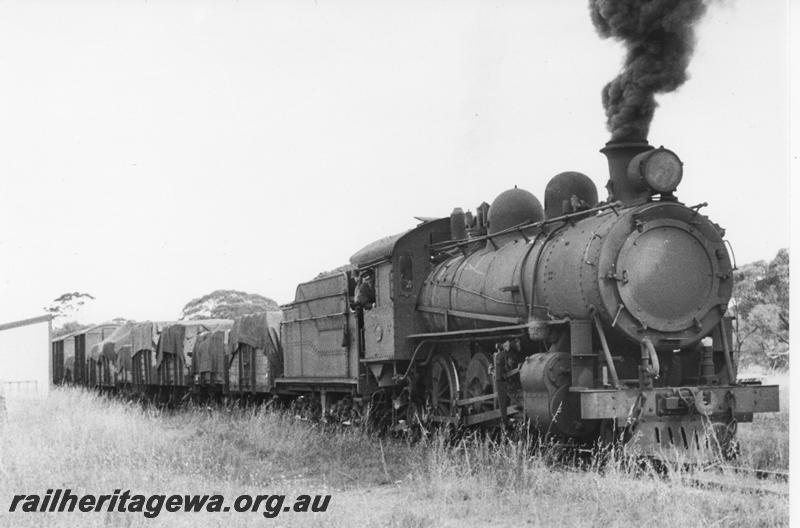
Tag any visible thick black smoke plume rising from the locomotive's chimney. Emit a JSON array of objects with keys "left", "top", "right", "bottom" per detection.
[{"left": 589, "top": 0, "right": 706, "bottom": 141}]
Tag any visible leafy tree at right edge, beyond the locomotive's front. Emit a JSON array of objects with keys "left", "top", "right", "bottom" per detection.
[{"left": 733, "top": 248, "right": 789, "bottom": 368}]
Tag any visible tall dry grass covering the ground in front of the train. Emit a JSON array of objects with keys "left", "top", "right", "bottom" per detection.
[{"left": 0, "top": 380, "right": 788, "bottom": 528}]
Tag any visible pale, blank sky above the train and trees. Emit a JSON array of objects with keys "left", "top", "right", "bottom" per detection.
[{"left": 0, "top": 0, "right": 789, "bottom": 322}]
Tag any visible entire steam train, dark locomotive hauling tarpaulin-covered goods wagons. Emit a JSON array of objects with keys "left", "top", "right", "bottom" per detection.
[{"left": 53, "top": 142, "right": 779, "bottom": 457}]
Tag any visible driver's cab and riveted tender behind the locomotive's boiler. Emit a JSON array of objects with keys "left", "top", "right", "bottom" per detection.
[{"left": 276, "top": 218, "right": 451, "bottom": 401}]
